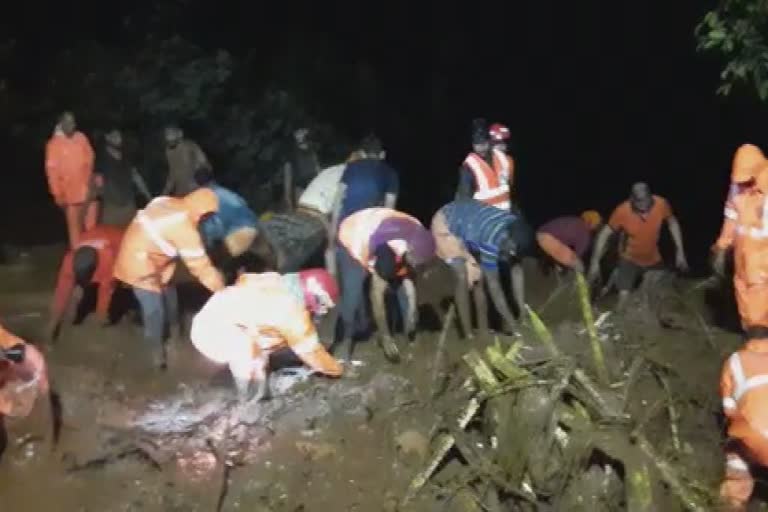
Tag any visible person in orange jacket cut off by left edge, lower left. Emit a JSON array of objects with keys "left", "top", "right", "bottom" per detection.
[{"left": 0, "top": 325, "right": 49, "bottom": 456}]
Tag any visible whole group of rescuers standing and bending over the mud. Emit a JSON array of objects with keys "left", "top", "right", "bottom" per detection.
[{"left": 0, "top": 113, "right": 768, "bottom": 507}]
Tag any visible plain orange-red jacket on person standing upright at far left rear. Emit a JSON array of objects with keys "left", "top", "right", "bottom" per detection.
[{"left": 45, "top": 129, "right": 93, "bottom": 204}]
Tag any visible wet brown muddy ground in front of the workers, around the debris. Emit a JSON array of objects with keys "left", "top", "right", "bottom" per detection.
[{"left": 0, "top": 247, "right": 752, "bottom": 512}]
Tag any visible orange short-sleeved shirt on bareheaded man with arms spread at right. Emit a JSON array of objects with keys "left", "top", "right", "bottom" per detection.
[{"left": 608, "top": 195, "right": 672, "bottom": 267}]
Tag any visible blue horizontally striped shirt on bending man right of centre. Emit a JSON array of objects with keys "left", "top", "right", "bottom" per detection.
[{"left": 441, "top": 199, "right": 519, "bottom": 270}]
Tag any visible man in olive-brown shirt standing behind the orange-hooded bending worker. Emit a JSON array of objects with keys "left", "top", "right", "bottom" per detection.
[{"left": 162, "top": 125, "right": 211, "bottom": 197}]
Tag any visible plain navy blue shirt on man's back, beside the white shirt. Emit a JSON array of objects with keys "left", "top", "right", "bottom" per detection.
[{"left": 340, "top": 159, "right": 400, "bottom": 219}]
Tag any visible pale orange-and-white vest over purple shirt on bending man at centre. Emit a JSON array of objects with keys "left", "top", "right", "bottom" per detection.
[{"left": 339, "top": 208, "right": 435, "bottom": 269}]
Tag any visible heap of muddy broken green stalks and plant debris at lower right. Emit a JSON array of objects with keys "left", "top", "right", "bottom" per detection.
[{"left": 401, "top": 276, "right": 721, "bottom": 512}]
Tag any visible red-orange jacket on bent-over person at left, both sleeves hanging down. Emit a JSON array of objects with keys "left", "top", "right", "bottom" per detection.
[{"left": 52, "top": 225, "right": 123, "bottom": 319}]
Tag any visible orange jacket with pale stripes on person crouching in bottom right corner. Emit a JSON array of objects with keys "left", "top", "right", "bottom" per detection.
[{"left": 720, "top": 340, "right": 768, "bottom": 465}]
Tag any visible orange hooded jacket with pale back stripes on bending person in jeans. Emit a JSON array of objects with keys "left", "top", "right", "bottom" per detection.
[{"left": 115, "top": 188, "right": 224, "bottom": 292}]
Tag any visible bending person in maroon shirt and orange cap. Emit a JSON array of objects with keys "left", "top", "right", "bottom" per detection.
[{"left": 536, "top": 210, "right": 602, "bottom": 273}]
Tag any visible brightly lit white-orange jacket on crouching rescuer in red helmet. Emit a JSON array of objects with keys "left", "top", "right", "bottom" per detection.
[{"left": 191, "top": 272, "right": 342, "bottom": 377}]
